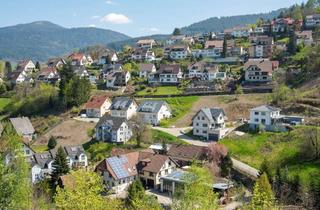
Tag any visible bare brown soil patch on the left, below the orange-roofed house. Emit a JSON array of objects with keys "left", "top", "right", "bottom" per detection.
[{"left": 34, "top": 119, "right": 95, "bottom": 146}]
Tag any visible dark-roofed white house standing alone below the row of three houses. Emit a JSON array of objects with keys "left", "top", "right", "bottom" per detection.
[{"left": 95, "top": 115, "right": 132, "bottom": 143}]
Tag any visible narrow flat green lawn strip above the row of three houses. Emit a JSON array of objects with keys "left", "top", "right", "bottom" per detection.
[{"left": 136, "top": 86, "right": 182, "bottom": 96}]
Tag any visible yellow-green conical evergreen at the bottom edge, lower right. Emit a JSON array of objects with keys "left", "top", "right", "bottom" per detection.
[{"left": 250, "top": 173, "right": 275, "bottom": 209}]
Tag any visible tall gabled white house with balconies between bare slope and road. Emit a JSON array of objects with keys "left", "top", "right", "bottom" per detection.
[{"left": 192, "top": 108, "right": 228, "bottom": 141}]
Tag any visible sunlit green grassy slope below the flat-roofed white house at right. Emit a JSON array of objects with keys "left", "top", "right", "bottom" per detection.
[{"left": 221, "top": 129, "right": 320, "bottom": 186}]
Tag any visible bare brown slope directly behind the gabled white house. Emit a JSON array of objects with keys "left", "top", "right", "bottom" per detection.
[{"left": 175, "top": 94, "right": 268, "bottom": 127}]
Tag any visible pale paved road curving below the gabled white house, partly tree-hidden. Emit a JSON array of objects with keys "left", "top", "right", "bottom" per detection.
[{"left": 154, "top": 127, "right": 259, "bottom": 178}]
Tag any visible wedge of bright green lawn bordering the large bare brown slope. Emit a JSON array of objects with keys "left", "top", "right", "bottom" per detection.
[{"left": 160, "top": 96, "right": 199, "bottom": 127}]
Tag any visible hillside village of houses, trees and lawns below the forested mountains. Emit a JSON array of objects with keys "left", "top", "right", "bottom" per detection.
[{"left": 0, "top": 0, "right": 320, "bottom": 209}]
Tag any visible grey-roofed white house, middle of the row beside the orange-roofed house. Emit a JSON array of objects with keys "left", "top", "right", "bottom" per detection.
[{"left": 110, "top": 97, "right": 138, "bottom": 120}]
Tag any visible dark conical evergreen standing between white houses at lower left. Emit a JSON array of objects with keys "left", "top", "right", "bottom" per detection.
[{"left": 51, "top": 147, "right": 70, "bottom": 187}]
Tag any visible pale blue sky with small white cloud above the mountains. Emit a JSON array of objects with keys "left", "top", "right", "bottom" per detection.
[{"left": 0, "top": 0, "right": 305, "bottom": 37}]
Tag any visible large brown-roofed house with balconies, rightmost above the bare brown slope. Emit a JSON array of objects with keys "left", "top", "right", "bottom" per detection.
[{"left": 244, "top": 59, "right": 279, "bottom": 83}]
